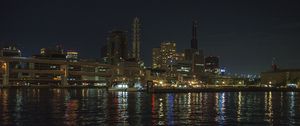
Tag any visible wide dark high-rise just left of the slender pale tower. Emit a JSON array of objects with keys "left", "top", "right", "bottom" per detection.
[{"left": 107, "top": 30, "right": 128, "bottom": 64}]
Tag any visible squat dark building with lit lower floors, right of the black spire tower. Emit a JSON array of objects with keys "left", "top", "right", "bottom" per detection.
[{"left": 205, "top": 56, "right": 220, "bottom": 75}]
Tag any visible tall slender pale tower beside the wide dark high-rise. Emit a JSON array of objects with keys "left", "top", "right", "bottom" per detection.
[{"left": 132, "top": 17, "right": 141, "bottom": 60}]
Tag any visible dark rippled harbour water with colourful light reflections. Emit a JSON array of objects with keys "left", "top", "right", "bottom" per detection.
[{"left": 0, "top": 89, "right": 300, "bottom": 126}]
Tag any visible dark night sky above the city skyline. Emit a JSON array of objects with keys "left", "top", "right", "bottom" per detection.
[{"left": 0, "top": 0, "right": 300, "bottom": 74}]
